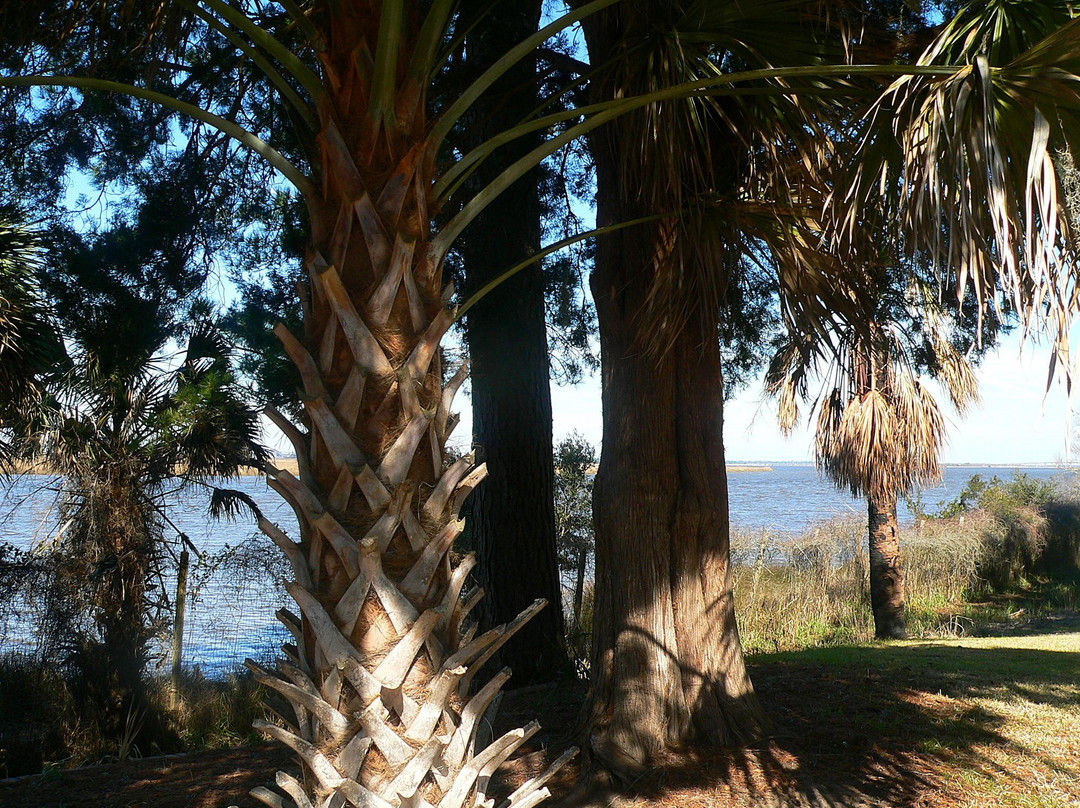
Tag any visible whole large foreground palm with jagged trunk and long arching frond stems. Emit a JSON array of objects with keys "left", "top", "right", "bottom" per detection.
[{"left": 4, "top": 0, "right": 591, "bottom": 807}]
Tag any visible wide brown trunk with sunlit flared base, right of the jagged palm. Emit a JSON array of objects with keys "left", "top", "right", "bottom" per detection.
[{"left": 588, "top": 171, "right": 761, "bottom": 777}]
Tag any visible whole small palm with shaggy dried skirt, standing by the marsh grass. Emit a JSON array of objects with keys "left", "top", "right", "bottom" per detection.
[{"left": 766, "top": 270, "right": 994, "bottom": 639}]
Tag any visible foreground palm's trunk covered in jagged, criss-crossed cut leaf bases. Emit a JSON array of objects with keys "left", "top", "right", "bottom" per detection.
[{"left": 248, "top": 2, "right": 574, "bottom": 808}]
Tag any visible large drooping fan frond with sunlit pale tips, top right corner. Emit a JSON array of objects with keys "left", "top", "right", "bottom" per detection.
[{"left": 835, "top": 2, "right": 1080, "bottom": 384}]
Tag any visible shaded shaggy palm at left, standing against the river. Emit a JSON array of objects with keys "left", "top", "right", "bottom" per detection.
[{"left": 13, "top": 266, "right": 266, "bottom": 752}]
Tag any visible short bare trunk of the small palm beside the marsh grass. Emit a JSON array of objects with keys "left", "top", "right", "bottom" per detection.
[{"left": 866, "top": 497, "right": 907, "bottom": 639}]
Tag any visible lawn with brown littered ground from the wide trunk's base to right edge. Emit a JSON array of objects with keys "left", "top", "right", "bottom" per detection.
[{"left": 596, "top": 616, "right": 1080, "bottom": 808}]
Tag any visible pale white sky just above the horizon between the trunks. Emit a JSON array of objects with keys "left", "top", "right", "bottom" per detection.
[{"left": 434, "top": 336, "right": 1076, "bottom": 466}]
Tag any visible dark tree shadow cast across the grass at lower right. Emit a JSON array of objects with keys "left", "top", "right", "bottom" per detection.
[{"left": 568, "top": 641, "right": 1080, "bottom": 808}]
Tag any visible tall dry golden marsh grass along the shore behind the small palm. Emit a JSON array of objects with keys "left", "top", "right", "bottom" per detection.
[{"left": 731, "top": 477, "right": 1080, "bottom": 654}]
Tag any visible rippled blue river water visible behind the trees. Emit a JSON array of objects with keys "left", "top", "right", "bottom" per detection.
[{"left": 0, "top": 463, "right": 1076, "bottom": 674}]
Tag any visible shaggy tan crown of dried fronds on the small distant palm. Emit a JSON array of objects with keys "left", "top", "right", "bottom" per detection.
[{"left": 766, "top": 249, "right": 977, "bottom": 501}]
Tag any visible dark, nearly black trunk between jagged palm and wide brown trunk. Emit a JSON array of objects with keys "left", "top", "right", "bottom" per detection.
[{"left": 462, "top": 0, "right": 569, "bottom": 686}]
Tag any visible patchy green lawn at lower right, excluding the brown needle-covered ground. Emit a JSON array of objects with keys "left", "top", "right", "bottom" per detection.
[{"left": 752, "top": 616, "right": 1080, "bottom": 808}]
